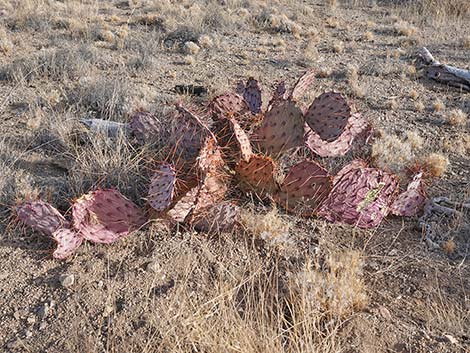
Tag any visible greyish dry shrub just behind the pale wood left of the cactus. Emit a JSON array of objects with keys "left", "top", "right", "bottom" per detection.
[{"left": 68, "top": 79, "right": 132, "bottom": 121}]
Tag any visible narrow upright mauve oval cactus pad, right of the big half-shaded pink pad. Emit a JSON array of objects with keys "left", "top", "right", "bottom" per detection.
[{"left": 147, "top": 163, "right": 176, "bottom": 212}]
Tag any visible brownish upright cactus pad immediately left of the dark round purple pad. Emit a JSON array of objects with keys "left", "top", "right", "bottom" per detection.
[{"left": 255, "top": 100, "right": 304, "bottom": 156}]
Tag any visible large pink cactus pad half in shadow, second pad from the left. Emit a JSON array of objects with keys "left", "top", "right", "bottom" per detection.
[{"left": 72, "top": 189, "right": 146, "bottom": 244}]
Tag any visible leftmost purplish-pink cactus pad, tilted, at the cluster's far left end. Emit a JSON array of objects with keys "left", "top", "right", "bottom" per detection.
[{"left": 16, "top": 200, "right": 69, "bottom": 236}]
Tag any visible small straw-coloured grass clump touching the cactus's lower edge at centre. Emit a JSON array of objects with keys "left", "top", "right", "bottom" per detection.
[{"left": 241, "top": 208, "right": 291, "bottom": 245}]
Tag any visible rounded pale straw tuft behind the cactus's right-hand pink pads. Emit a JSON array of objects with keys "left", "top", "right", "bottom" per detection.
[{"left": 372, "top": 133, "right": 415, "bottom": 173}]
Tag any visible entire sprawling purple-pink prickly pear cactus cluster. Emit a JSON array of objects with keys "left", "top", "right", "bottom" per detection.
[{"left": 17, "top": 71, "right": 425, "bottom": 258}]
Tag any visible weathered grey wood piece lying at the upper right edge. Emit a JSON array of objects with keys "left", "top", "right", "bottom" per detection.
[{"left": 418, "top": 48, "right": 470, "bottom": 92}]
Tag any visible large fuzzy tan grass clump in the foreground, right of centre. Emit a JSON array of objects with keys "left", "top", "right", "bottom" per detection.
[{"left": 294, "top": 250, "right": 367, "bottom": 318}]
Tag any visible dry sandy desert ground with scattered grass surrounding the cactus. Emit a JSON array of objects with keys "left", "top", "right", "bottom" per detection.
[{"left": 0, "top": 0, "right": 470, "bottom": 353}]
